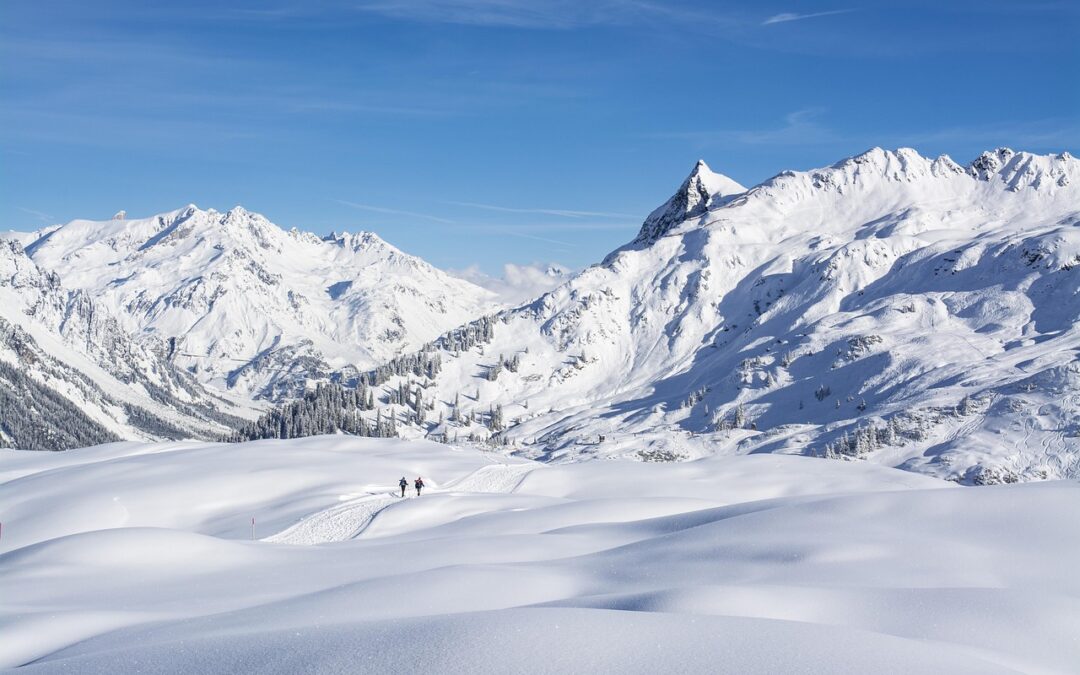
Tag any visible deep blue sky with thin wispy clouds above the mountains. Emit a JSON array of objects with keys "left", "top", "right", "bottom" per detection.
[{"left": 0, "top": 0, "right": 1080, "bottom": 273}]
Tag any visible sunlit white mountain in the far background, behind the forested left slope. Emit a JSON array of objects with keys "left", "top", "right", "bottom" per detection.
[{"left": 26, "top": 205, "right": 495, "bottom": 399}]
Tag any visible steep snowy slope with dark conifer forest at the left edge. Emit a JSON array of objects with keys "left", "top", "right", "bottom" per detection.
[{"left": 0, "top": 240, "right": 249, "bottom": 449}]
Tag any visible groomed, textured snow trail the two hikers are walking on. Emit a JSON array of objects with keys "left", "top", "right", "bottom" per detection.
[{"left": 262, "top": 462, "right": 537, "bottom": 546}]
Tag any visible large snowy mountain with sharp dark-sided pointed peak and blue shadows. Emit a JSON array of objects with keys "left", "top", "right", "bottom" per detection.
[{"left": 358, "top": 149, "right": 1080, "bottom": 483}]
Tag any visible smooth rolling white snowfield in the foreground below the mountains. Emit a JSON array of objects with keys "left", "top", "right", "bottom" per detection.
[{"left": 0, "top": 436, "right": 1080, "bottom": 674}]
